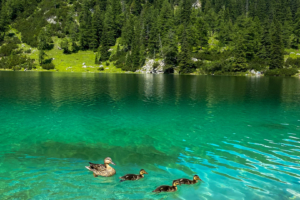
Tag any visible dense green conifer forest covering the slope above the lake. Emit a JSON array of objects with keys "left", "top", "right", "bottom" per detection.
[{"left": 0, "top": 0, "right": 300, "bottom": 75}]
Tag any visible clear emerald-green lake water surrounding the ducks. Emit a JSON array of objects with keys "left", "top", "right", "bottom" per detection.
[{"left": 0, "top": 72, "right": 300, "bottom": 200}]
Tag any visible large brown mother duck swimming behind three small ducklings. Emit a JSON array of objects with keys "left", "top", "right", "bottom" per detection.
[{"left": 85, "top": 157, "right": 116, "bottom": 177}]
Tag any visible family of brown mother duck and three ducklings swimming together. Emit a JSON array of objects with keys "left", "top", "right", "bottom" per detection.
[{"left": 86, "top": 157, "right": 202, "bottom": 193}]
